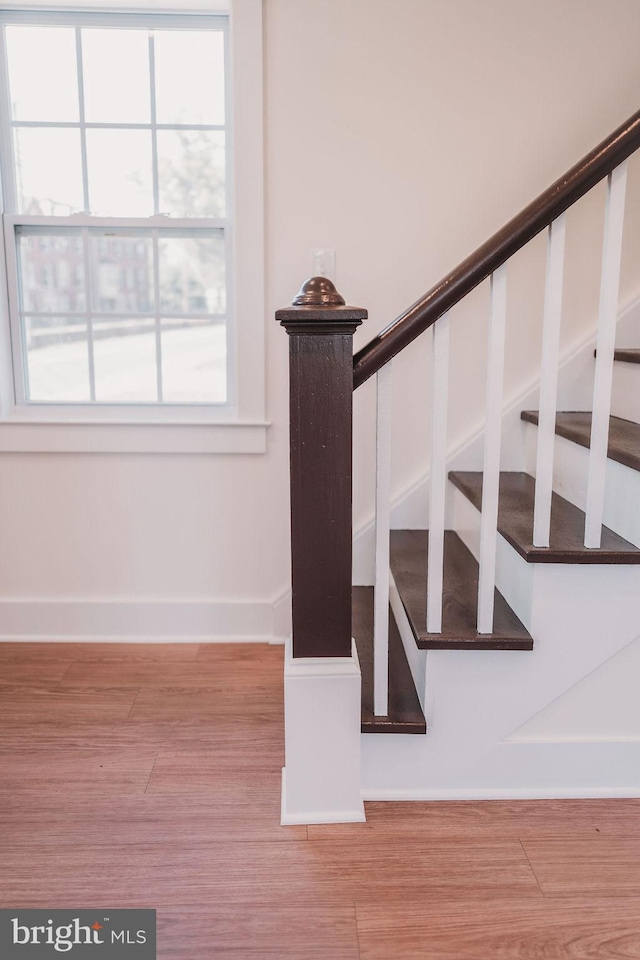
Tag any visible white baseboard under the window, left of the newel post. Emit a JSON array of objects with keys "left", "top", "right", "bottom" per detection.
[{"left": 0, "top": 599, "right": 283, "bottom": 643}]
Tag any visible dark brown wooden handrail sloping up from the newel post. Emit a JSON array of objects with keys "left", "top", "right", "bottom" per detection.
[{"left": 353, "top": 110, "right": 640, "bottom": 389}]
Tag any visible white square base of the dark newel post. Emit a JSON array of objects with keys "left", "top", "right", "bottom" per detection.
[{"left": 281, "top": 639, "right": 365, "bottom": 824}]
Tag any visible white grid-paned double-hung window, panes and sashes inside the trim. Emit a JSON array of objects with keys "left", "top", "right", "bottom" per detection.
[{"left": 4, "top": 17, "right": 230, "bottom": 403}]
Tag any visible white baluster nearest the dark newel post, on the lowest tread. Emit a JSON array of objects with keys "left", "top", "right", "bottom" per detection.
[{"left": 373, "top": 361, "right": 391, "bottom": 717}]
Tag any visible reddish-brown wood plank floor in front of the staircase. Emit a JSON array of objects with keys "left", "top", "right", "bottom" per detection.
[{"left": 0, "top": 643, "right": 640, "bottom": 960}]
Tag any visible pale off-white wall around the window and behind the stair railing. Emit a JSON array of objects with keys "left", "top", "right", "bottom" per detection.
[{"left": 0, "top": 0, "right": 640, "bottom": 634}]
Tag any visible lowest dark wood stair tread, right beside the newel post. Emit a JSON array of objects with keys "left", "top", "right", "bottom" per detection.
[{"left": 352, "top": 587, "right": 427, "bottom": 733}]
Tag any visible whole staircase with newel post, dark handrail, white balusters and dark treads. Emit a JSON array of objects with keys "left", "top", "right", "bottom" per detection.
[{"left": 277, "top": 107, "right": 640, "bottom": 822}]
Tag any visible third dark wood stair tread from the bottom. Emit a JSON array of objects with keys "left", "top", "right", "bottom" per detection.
[{"left": 449, "top": 470, "right": 640, "bottom": 563}]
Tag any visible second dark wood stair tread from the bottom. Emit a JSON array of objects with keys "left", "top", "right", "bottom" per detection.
[{"left": 391, "top": 530, "right": 533, "bottom": 650}]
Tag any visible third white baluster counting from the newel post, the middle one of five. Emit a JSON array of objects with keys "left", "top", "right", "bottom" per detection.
[{"left": 478, "top": 264, "right": 507, "bottom": 633}]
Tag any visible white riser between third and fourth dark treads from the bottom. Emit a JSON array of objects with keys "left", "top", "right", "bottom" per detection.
[{"left": 525, "top": 420, "right": 640, "bottom": 547}]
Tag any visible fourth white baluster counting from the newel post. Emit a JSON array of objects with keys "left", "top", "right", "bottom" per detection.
[{"left": 533, "top": 213, "right": 566, "bottom": 547}]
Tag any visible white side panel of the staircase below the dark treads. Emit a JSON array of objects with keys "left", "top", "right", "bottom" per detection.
[{"left": 362, "top": 492, "right": 640, "bottom": 799}]
